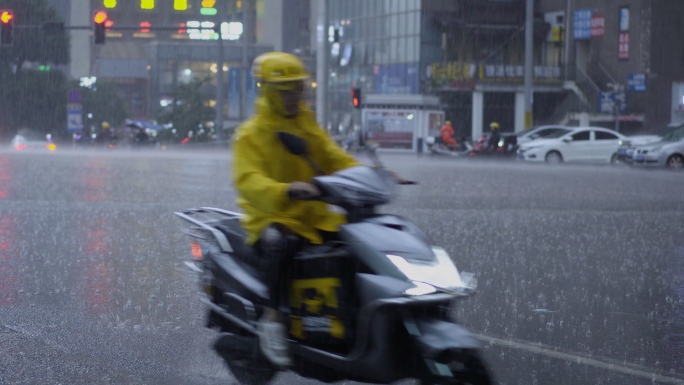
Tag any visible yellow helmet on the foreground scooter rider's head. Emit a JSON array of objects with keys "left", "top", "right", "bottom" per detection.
[{"left": 252, "top": 52, "right": 309, "bottom": 83}]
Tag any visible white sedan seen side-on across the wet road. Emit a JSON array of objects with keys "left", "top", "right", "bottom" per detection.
[{"left": 517, "top": 127, "right": 625, "bottom": 163}]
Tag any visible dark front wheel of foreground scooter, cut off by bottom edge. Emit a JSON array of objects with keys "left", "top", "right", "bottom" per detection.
[{"left": 420, "top": 350, "right": 494, "bottom": 385}]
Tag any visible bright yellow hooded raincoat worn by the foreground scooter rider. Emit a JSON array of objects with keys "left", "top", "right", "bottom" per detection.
[{"left": 233, "top": 96, "right": 358, "bottom": 245}]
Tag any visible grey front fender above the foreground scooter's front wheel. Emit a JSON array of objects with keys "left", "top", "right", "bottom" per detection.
[{"left": 404, "top": 317, "right": 482, "bottom": 361}]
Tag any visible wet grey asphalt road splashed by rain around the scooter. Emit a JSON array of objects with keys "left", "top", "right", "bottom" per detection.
[{"left": 0, "top": 150, "right": 684, "bottom": 384}]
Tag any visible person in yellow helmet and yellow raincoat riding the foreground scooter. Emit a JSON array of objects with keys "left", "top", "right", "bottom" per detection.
[{"left": 233, "top": 52, "right": 358, "bottom": 367}]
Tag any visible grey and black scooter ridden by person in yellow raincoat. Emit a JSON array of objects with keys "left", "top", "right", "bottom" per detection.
[{"left": 175, "top": 132, "right": 492, "bottom": 385}]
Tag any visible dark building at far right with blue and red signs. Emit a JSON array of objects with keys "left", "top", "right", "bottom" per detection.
[{"left": 538, "top": 0, "right": 684, "bottom": 133}]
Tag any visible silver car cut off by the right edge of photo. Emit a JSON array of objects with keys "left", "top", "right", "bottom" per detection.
[{"left": 634, "top": 127, "right": 684, "bottom": 170}]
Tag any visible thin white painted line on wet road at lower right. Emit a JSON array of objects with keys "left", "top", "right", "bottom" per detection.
[{"left": 476, "top": 334, "right": 684, "bottom": 385}]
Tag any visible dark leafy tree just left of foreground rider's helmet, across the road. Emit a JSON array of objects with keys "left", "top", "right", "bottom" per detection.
[{"left": 158, "top": 78, "right": 216, "bottom": 140}]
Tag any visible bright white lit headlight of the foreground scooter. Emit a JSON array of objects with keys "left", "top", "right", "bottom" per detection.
[{"left": 387, "top": 247, "right": 475, "bottom": 295}]
